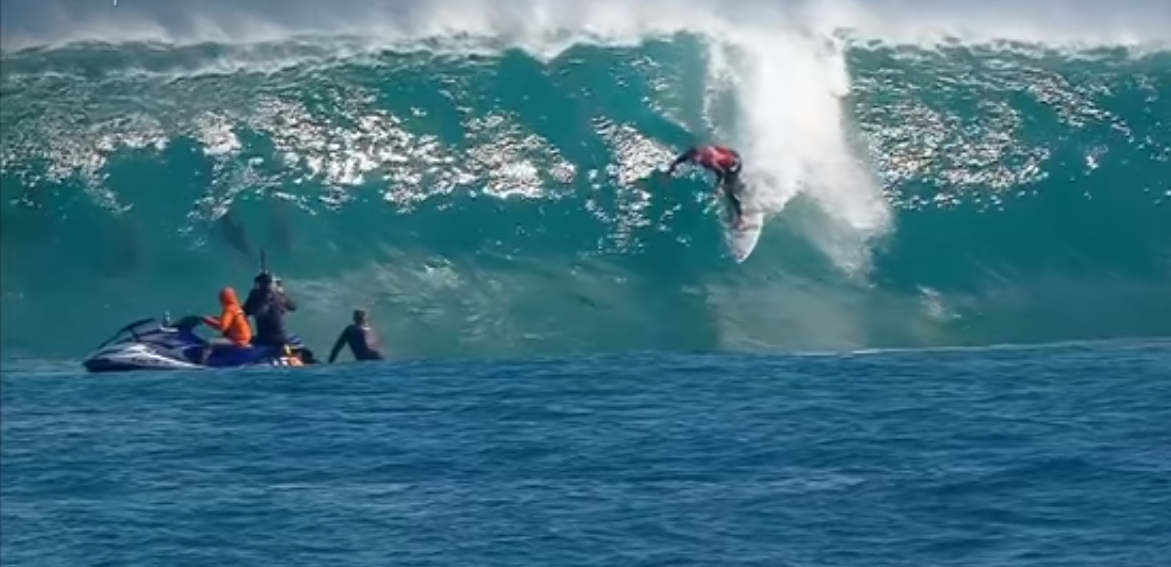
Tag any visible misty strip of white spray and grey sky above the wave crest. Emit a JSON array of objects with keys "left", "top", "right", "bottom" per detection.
[{"left": 0, "top": 0, "right": 1171, "bottom": 50}]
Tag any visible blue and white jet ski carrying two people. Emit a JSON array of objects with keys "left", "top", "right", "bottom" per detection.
[{"left": 82, "top": 315, "right": 316, "bottom": 373}]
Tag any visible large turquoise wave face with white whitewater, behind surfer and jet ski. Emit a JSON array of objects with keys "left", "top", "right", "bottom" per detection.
[{"left": 0, "top": 26, "right": 1171, "bottom": 358}]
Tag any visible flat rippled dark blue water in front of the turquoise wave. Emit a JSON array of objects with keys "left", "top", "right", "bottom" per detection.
[{"left": 0, "top": 341, "right": 1171, "bottom": 567}]
